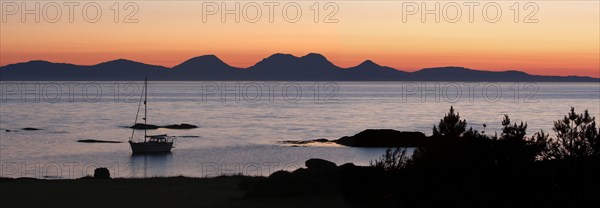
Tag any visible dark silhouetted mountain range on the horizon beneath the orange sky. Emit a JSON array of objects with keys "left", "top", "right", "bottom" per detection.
[{"left": 0, "top": 53, "right": 600, "bottom": 82}]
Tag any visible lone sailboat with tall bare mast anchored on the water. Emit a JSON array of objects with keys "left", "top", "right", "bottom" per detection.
[{"left": 129, "top": 78, "right": 175, "bottom": 154}]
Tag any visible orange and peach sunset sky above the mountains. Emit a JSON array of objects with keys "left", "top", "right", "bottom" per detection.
[{"left": 0, "top": 0, "right": 600, "bottom": 77}]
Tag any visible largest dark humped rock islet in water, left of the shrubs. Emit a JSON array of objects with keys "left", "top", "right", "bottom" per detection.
[{"left": 334, "top": 129, "right": 427, "bottom": 147}]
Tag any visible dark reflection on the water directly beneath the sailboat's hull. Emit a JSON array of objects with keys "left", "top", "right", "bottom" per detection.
[{"left": 129, "top": 152, "right": 173, "bottom": 178}]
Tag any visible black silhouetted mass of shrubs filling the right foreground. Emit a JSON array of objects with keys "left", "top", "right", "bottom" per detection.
[{"left": 364, "top": 107, "right": 600, "bottom": 207}]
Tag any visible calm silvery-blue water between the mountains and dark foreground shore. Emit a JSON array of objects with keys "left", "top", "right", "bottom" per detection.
[{"left": 0, "top": 82, "right": 600, "bottom": 178}]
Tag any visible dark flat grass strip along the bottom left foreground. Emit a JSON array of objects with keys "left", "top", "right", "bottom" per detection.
[{"left": 0, "top": 176, "right": 346, "bottom": 207}]
